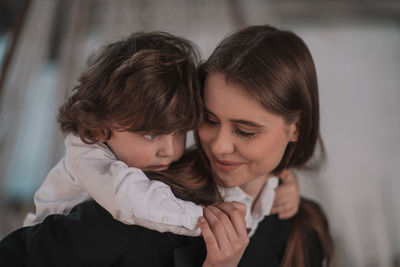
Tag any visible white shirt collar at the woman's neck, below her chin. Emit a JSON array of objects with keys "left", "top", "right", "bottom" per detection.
[{"left": 218, "top": 176, "right": 279, "bottom": 236}]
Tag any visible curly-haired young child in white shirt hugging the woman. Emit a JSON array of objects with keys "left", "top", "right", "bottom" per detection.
[{"left": 24, "top": 30, "right": 293, "bottom": 236}]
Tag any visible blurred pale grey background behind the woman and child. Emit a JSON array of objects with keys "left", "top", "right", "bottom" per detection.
[{"left": 0, "top": 0, "right": 400, "bottom": 266}]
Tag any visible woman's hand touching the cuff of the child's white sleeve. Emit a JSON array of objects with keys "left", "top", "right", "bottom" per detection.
[{"left": 199, "top": 202, "right": 249, "bottom": 267}]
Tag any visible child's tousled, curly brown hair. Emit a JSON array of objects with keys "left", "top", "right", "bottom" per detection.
[{"left": 58, "top": 32, "right": 202, "bottom": 144}]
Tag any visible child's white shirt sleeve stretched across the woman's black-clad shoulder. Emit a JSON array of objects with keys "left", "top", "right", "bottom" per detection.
[{"left": 65, "top": 136, "right": 203, "bottom": 236}]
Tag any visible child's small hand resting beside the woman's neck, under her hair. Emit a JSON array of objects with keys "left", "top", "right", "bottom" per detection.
[{"left": 271, "top": 170, "right": 300, "bottom": 220}]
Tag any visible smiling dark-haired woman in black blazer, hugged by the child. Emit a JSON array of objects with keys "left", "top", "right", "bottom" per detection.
[{"left": 0, "top": 26, "right": 332, "bottom": 266}]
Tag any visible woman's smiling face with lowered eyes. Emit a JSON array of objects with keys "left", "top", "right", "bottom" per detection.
[{"left": 198, "top": 73, "right": 297, "bottom": 194}]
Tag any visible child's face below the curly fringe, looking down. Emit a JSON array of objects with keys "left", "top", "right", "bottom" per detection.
[{"left": 106, "top": 131, "right": 186, "bottom": 171}]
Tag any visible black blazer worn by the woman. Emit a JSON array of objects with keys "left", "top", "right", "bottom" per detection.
[{"left": 0, "top": 201, "right": 322, "bottom": 267}]
